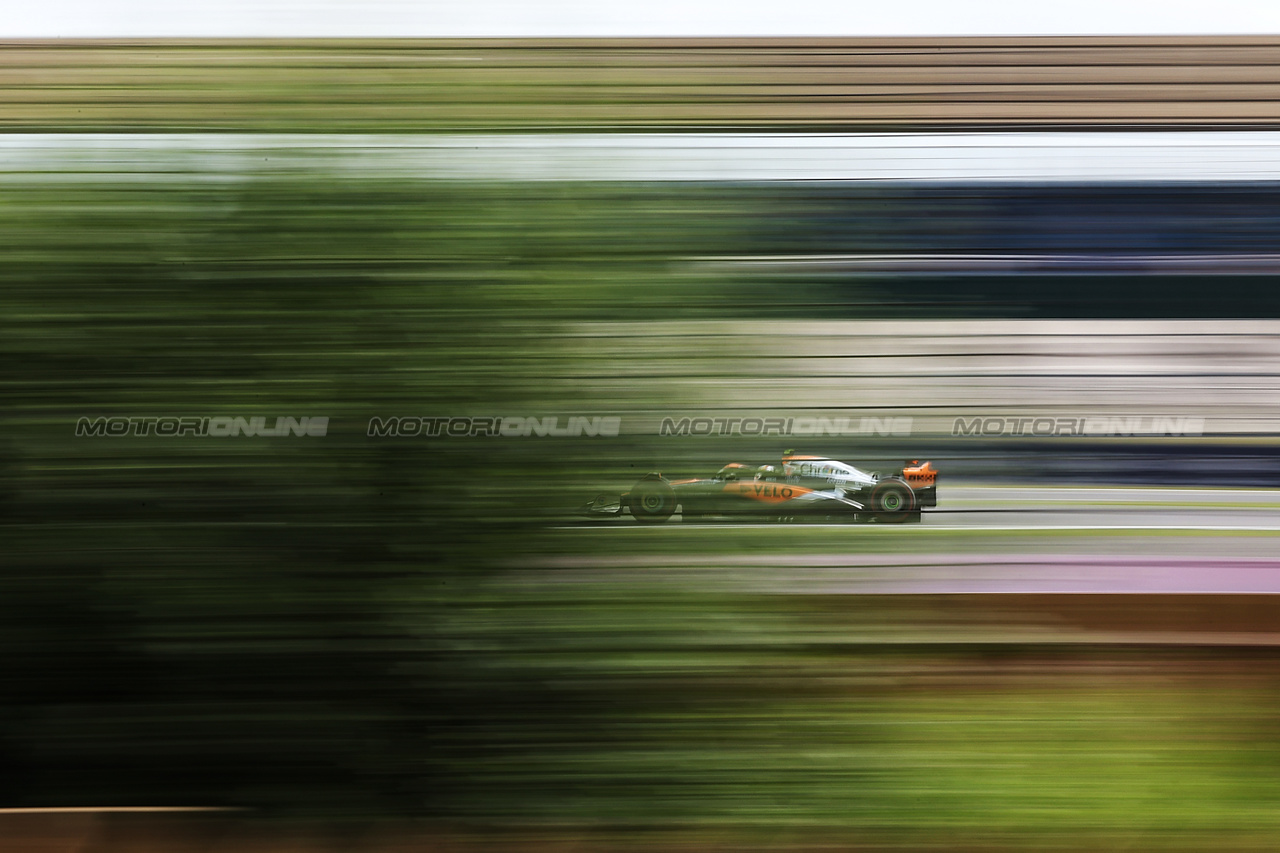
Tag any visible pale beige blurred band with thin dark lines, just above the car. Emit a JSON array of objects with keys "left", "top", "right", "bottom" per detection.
[{"left": 570, "top": 320, "right": 1280, "bottom": 437}]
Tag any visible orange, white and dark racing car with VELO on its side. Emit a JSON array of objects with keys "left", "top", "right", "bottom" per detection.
[{"left": 582, "top": 451, "right": 938, "bottom": 524}]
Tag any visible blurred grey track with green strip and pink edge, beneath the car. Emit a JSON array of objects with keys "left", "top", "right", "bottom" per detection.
[{"left": 547, "top": 485, "right": 1280, "bottom": 594}]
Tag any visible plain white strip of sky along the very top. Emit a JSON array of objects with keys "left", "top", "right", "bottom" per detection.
[{"left": 0, "top": 0, "right": 1280, "bottom": 38}]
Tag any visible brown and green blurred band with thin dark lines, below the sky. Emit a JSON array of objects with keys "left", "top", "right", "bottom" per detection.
[{"left": 0, "top": 37, "right": 1280, "bottom": 132}]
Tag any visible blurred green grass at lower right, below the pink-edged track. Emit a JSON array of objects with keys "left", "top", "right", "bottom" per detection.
[{"left": 432, "top": 583, "right": 1280, "bottom": 849}]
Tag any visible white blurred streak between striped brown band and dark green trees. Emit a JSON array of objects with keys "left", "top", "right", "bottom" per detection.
[{"left": 12, "top": 131, "right": 1280, "bottom": 180}]
